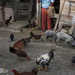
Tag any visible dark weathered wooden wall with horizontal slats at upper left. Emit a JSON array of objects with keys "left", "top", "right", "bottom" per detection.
[{"left": 6, "top": 0, "right": 32, "bottom": 20}]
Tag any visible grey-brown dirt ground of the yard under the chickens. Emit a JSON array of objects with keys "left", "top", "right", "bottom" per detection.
[{"left": 0, "top": 20, "right": 75, "bottom": 75}]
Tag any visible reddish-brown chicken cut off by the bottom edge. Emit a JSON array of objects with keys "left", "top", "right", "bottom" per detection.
[{"left": 11, "top": 68, "right": 38, "bottom": 75}]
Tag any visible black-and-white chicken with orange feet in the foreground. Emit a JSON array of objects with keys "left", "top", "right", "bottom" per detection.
[{"left": 36, "top": 49, "right": 55, "bottom": 71}]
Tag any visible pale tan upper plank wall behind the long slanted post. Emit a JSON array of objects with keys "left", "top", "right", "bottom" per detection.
[{"left": 60, "top": 0, "right": 75, "bottom": 17}]
